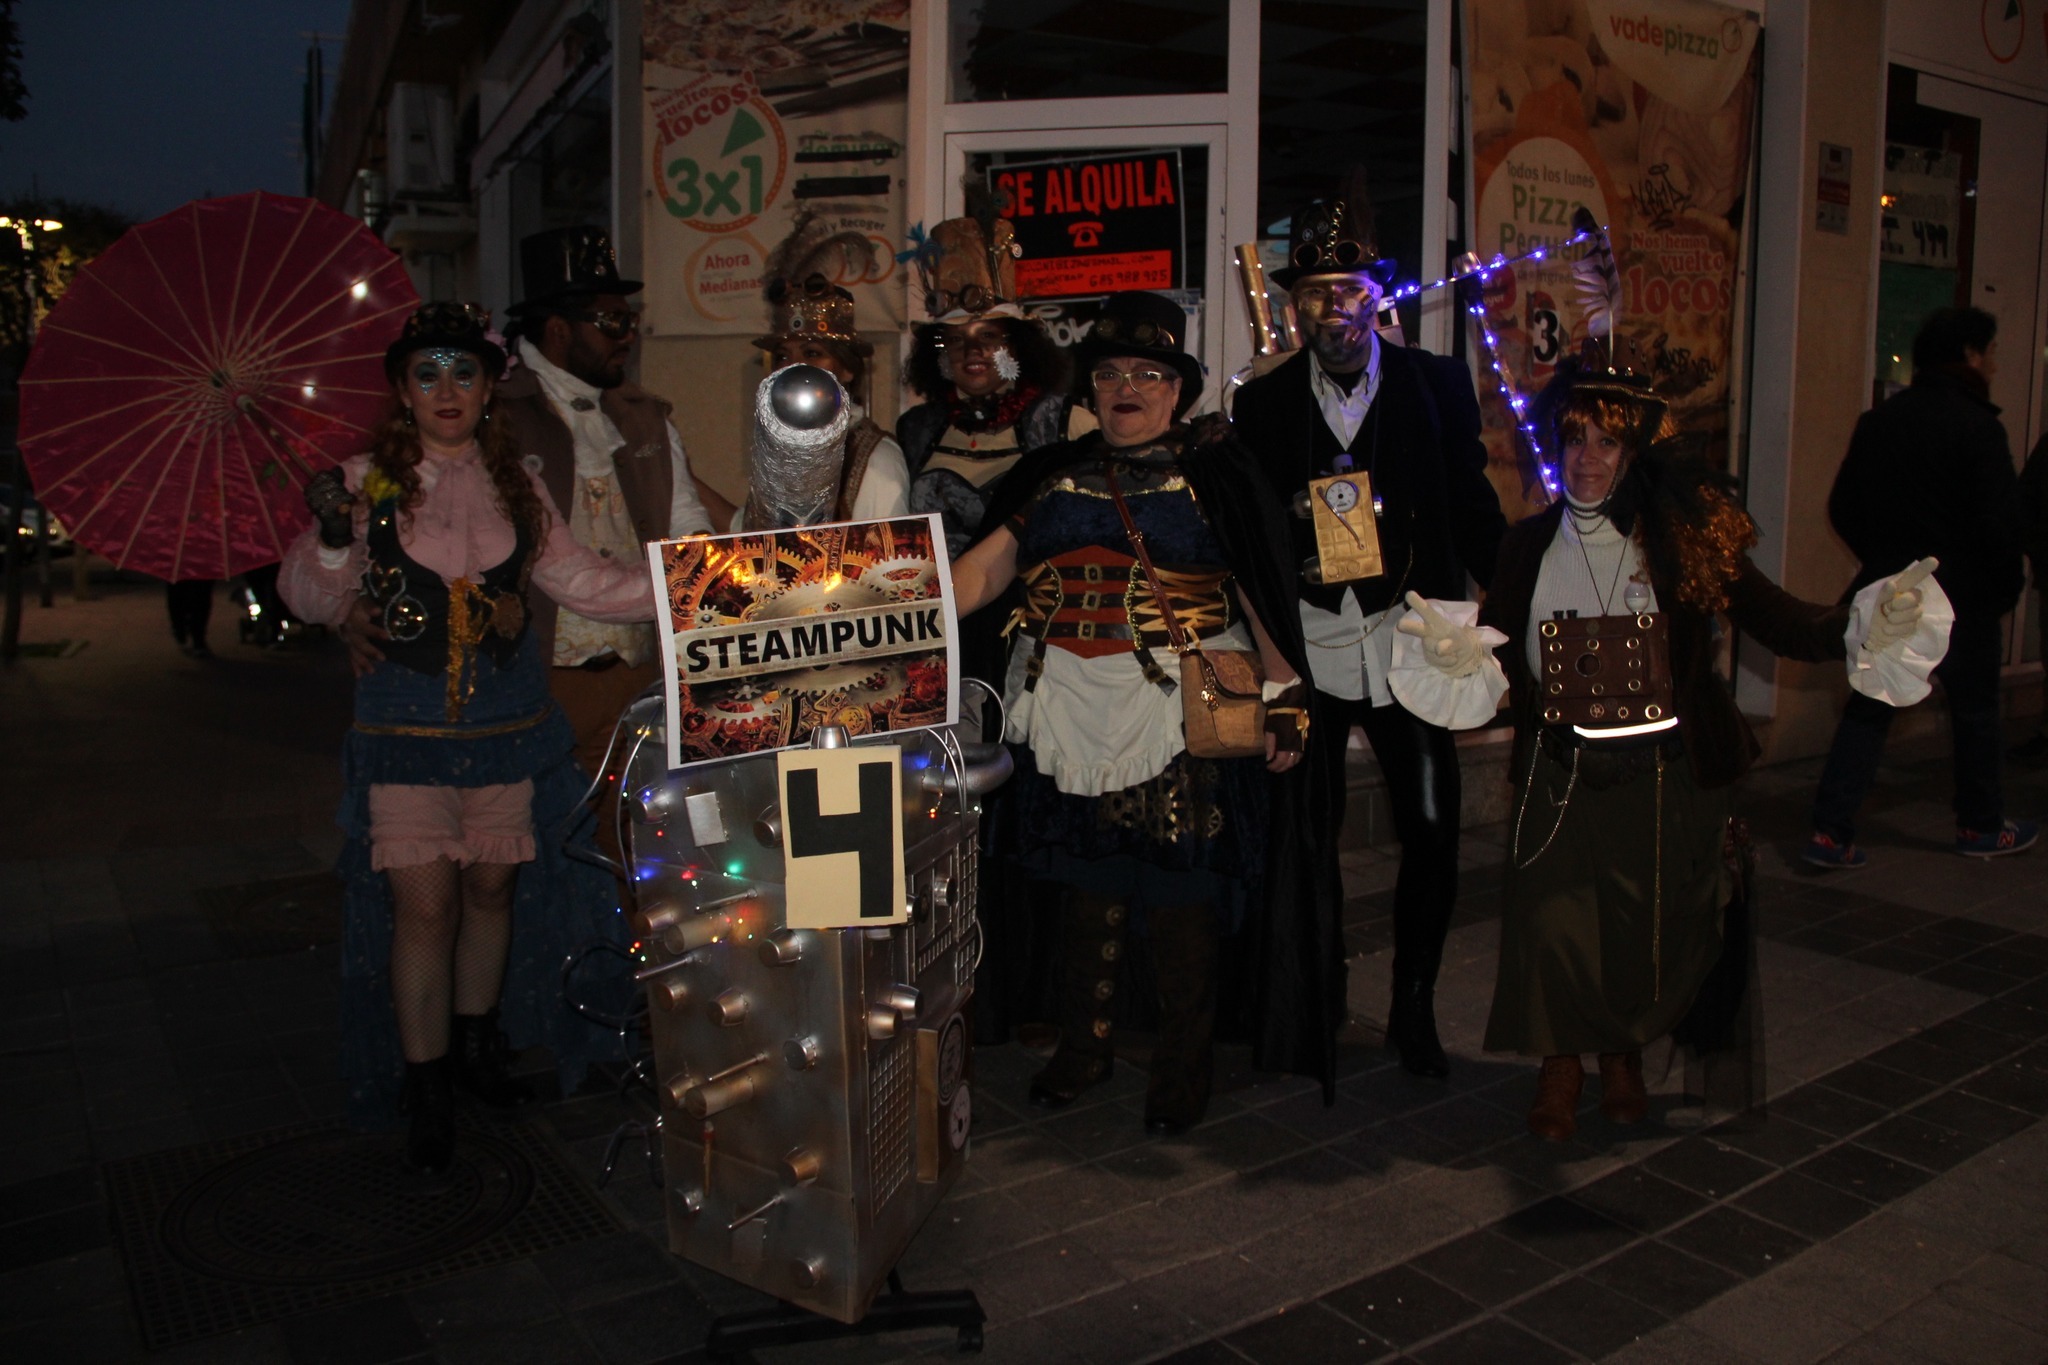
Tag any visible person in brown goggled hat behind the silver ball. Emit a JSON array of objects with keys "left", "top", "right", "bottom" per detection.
[{"left": 754, "top": 274, "right": 909, "bottom": 522}]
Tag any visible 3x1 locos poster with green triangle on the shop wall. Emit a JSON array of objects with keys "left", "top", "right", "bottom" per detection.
[{"left": 641, "top": 0, "right": 909, "bottom": 336}]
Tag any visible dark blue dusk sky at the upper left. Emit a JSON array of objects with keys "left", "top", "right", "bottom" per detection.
[{"left": 0, "top": 0, "right": 350, "bottom": 219}]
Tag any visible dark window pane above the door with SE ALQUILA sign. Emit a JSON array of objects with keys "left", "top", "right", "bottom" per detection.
[{"left": 948, "top": 0, "right": 1220, "bottom": 104}]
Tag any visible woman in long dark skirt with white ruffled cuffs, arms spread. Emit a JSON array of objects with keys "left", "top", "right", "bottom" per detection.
[{"left": 1393, "top": 347, "right": 1948, "bottom": 1142}]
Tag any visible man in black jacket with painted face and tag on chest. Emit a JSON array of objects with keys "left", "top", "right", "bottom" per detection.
[{"left": 1233, "top": 199, "right": 1507, "bottom": 1076}]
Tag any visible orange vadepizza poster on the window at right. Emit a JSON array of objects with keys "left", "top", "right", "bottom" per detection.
[{"left": 1464, "top": 0, "right": 1759, "bottom": 514}]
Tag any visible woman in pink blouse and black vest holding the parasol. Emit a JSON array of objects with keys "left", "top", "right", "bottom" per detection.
[{"left": 279, "top": 303, "right": 655, "bottom": 1173}]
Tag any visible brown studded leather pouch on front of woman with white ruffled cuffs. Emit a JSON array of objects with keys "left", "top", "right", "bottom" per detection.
[{"left": 1536, "top": 612, "right": 1677, "bottom": 731}]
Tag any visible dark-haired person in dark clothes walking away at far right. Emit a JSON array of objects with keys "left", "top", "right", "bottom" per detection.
[{"left": 1804, "top": 307, "right": 2040, "bottom": 868}]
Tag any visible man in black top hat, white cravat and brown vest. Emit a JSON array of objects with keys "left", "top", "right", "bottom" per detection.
[{"left": 494, "top": 227, "right": 731, "bottom": 875}]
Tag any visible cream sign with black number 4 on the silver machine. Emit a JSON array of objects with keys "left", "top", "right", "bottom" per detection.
[{"left": 776, "top": 745, "right": 909, "bottom": 929}]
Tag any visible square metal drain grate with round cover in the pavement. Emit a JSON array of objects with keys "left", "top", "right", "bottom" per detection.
[{"left": 104, "top": 1124, "right": 618, "bottom": 1351}]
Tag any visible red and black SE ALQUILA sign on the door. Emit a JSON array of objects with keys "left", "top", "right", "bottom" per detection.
[{"left": 987, "top": 147, "right": 1188, "bottom": 299}]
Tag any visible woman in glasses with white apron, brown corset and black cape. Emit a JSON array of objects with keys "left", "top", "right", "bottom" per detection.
[{"left": 954, "top": 293, "right": 1337, "bottom": 1134}]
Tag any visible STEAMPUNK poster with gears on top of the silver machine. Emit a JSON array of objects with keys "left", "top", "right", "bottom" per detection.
[{"left": 647, "top": 516, "right": 961, "bottom": 767}]
